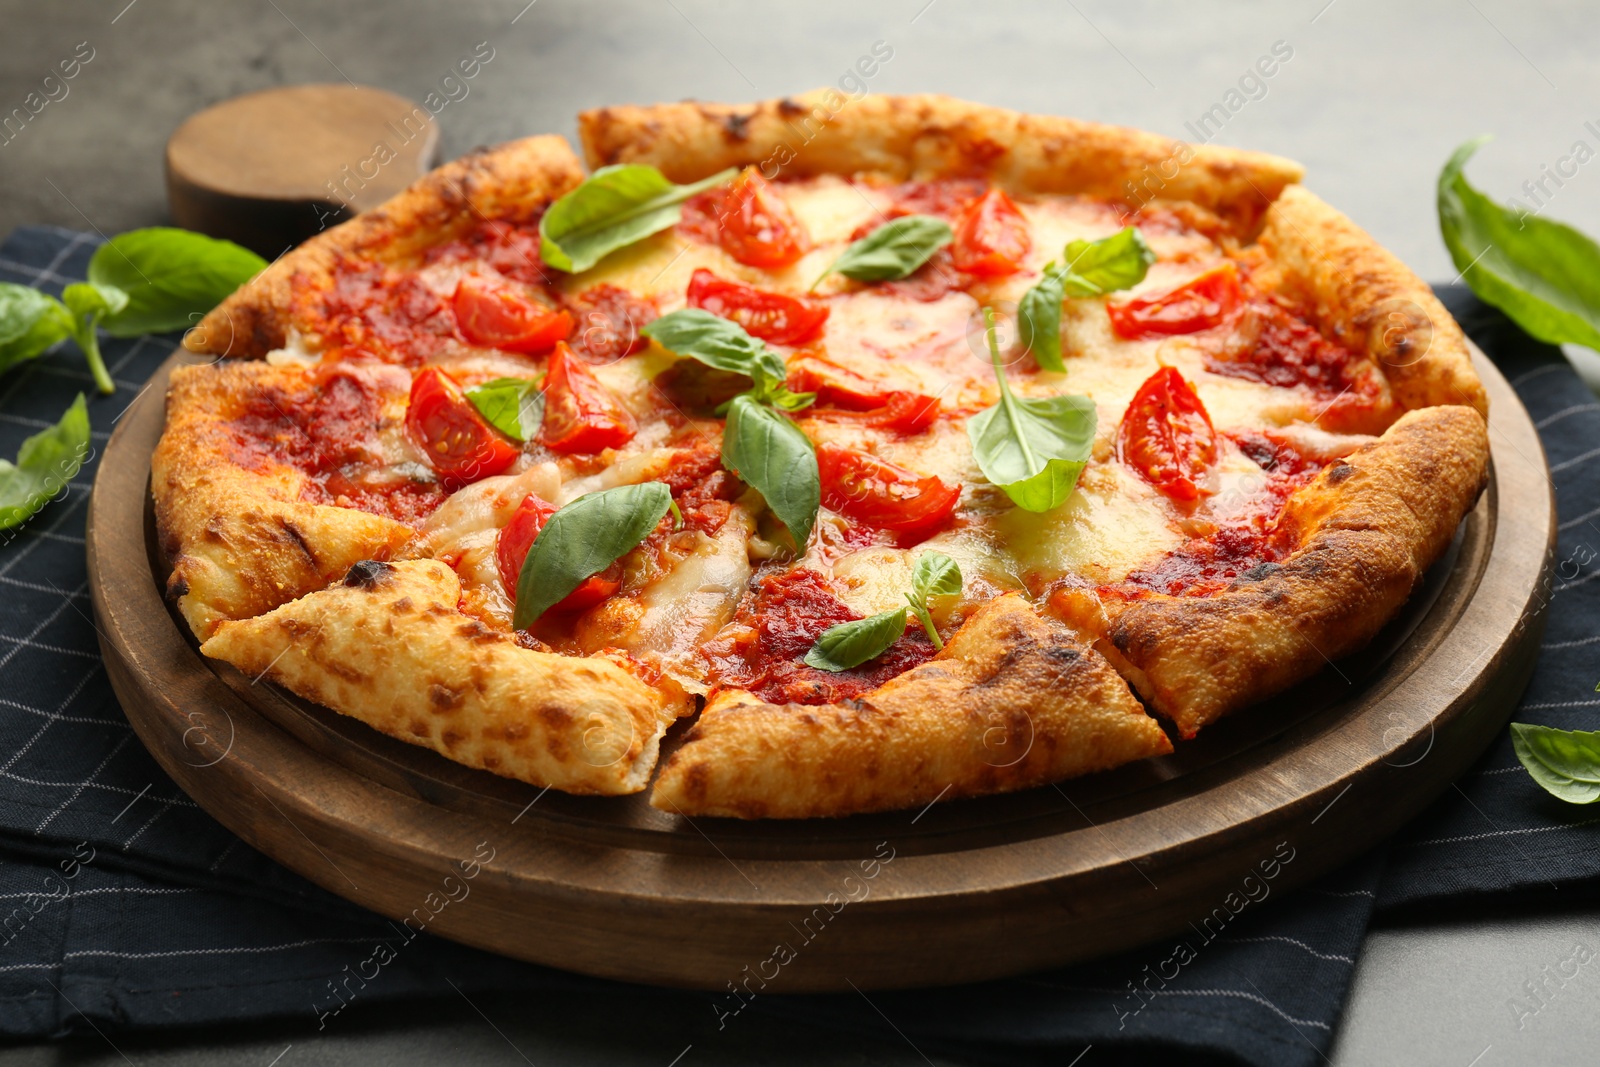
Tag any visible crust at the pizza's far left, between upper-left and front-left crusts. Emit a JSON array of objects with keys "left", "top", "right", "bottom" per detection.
[{"left": 150, "top": 363, "right": 414, "bottom": 641}]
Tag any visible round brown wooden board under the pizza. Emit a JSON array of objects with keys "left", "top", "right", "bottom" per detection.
[{"left": 88, "top": 352, "right": 1555, "bottom": 992}]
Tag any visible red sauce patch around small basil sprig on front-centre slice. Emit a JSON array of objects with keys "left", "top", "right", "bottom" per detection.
[{"left": 706, "top": 568, "right": 934, "bottom": 704}]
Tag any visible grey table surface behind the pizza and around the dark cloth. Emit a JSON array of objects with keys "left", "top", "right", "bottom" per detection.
[{"left": 0, "top": 0, "right": 1600, "bottom": 1067}]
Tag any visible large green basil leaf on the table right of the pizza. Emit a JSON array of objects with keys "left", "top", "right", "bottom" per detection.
[{"left": 1438, "top": 136, "right": 1600, "bottom": 349}]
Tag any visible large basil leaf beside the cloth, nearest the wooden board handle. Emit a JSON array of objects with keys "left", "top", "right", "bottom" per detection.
[{"left": 88, "top": 226, "right": 267, "bottom": 338}]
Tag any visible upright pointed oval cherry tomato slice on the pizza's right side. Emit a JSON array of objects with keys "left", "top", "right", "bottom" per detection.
[{"left": 1117, "top": 366, "right": 1216, "bottom": 501}]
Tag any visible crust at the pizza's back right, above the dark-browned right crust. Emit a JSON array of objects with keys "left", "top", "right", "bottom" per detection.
[{"left": 1261, "top": 186, "right": 1490, "bottom": 418}]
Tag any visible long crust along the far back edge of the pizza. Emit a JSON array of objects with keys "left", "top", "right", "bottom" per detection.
[{"left": 578, "top": 90, "right": 1304, "bottom": 232}]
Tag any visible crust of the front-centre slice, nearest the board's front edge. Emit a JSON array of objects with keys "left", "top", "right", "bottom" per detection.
[{"left": 650, "top": 593, "right": 1171, "bottom": 819}]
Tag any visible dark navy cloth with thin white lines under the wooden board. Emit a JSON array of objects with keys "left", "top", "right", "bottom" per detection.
[{"left": 0, "top": 227, "right": 1600, "bottom": 1065}]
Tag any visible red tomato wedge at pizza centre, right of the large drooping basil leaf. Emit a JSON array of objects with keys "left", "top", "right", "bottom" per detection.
[{"left": 816, "top": 445, "right": 962, "bottom": 541}]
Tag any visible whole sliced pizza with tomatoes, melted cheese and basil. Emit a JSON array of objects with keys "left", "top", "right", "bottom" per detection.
[{"left": 152, "top": 96, "right": 1488, "bottom": 817}]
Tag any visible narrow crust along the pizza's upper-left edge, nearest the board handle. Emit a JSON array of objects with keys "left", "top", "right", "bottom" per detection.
[{"left": 184, "top": 134, "right": 584, "bottom": 358}]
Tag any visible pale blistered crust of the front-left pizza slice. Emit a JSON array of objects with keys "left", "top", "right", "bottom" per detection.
[{"left": 200, "top": 560, "right": 686, "bottom": 795}]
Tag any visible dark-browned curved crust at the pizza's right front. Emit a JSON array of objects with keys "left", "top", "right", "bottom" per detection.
[{"left": 1058, "top": 406, "right": 1490, "bottom": 737}]
